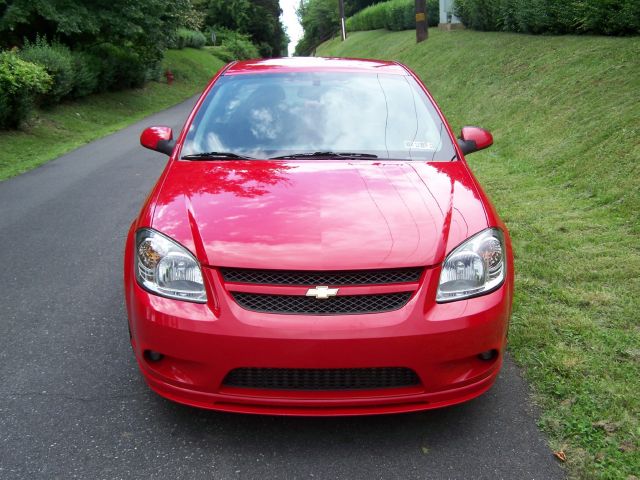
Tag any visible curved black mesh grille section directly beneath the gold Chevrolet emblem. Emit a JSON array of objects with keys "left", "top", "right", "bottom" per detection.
[{"left": 232, "top": 292, "right": 411, "bottom": 315}]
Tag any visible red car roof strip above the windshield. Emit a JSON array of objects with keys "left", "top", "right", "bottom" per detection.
[{"left": 224, "top": 57, "right": 408, "bottom": 75}]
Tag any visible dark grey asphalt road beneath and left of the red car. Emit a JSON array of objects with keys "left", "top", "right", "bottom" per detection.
[{"left": 0, "top": 95, "right": 563, "bottom": 480}]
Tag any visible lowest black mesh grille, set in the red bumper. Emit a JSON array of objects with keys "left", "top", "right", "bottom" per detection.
[{"left": 223, "top": 367, "right": 420, "bottom": 390}]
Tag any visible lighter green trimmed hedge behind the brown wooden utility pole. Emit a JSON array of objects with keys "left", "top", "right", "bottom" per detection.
[{"left": 347, "top": 0, "right": 439, "bottom": 31}]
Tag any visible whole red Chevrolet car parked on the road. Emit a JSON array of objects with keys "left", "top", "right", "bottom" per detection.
[{"left": 124, "top": 58, "right": 513, "bottom": 415}]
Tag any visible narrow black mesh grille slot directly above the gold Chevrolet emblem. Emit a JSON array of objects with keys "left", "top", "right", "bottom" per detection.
[{"left": 220, "top": 267, "right": 423, "bottom": 286}]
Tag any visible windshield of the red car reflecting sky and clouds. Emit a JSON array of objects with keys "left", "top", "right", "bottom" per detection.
[{"left": 182, "top": 72, "right": 455, "bottom": 161}]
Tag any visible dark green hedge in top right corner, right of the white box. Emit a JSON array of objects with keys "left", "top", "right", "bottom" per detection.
[{"left": 455, "top": 0, "right": 640, "bottom": 35}]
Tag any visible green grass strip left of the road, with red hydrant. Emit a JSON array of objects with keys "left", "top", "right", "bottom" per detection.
[{"left": 0, "top": 48, "right": 223, "bottom": 180}]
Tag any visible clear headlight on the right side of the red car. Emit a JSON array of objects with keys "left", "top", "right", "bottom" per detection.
[{"left": 436, "top": 228, "right": 507, "bottom": 302}]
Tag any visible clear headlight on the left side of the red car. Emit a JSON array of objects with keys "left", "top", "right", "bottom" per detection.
[{"left": 135, "top": 228, "right": 207, "bottom": 303}]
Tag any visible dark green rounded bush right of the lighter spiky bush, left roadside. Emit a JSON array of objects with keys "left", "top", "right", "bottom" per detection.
[{"left": 90, "top": 43, "right": 148, "bottom": 91}]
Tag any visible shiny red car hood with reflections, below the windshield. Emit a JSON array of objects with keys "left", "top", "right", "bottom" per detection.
[{"left": 151, "top": 160, "right": 487, "bottom": 270}]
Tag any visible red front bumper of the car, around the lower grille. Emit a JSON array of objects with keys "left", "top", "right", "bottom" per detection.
[{"left": 125, "top": 258, "right": 511, "bottom": 415}]
